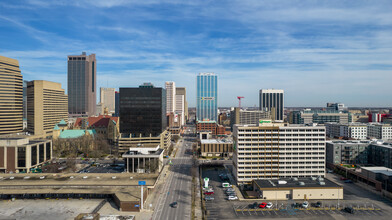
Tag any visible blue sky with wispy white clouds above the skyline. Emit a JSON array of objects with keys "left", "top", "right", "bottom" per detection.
[{"left": 0, "top": 0, "right": 392, "bottom": 107}]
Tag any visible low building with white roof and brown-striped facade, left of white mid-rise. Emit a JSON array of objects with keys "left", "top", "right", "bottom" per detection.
[{"left": 200, "top": 139, "right": 233, "bottom": 157}]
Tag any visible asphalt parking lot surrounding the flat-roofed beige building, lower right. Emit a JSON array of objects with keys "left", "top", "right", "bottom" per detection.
[{"left": 202, "top": 166, "right": 392, "bottom": 219}]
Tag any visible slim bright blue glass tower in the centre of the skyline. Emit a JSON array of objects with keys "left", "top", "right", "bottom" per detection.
[{"left": 196, "top": 73, "right": 218, "bottom": 121}]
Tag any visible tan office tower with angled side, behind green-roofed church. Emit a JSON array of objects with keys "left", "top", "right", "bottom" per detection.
[{"left": 27, "top": 80, "right": 68, "bottom": 138}]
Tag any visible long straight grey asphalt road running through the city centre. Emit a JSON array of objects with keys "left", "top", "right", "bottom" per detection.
[{"left": 153, "top": 129, "right": 193, "bottom": 220}]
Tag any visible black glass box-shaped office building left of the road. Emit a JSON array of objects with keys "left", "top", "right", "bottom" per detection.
[{"left": 120, "top": 83, "right": 167, "bottom": 136}]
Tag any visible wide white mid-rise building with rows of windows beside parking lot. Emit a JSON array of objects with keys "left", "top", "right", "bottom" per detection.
[{"left": 233, "top": 122, "right": 325, "bottom": 184}]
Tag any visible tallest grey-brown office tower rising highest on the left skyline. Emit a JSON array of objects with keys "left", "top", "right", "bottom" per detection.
[{"left": 68, "top": 52, "right": 97, "bottom": 116}]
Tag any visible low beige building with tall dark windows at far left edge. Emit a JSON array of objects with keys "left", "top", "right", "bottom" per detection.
[{"left": 0, "top": 137, "right": 52, "bottom": 173}]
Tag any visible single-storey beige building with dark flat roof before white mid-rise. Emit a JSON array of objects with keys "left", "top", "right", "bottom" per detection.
[{"left": 252, "top": 177, "right": 343, "bottom": 200}]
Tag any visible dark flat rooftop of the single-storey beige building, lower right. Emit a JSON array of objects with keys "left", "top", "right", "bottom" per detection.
[{"left": 254, "top": 177, "right": 342, "bottom": 189}]
